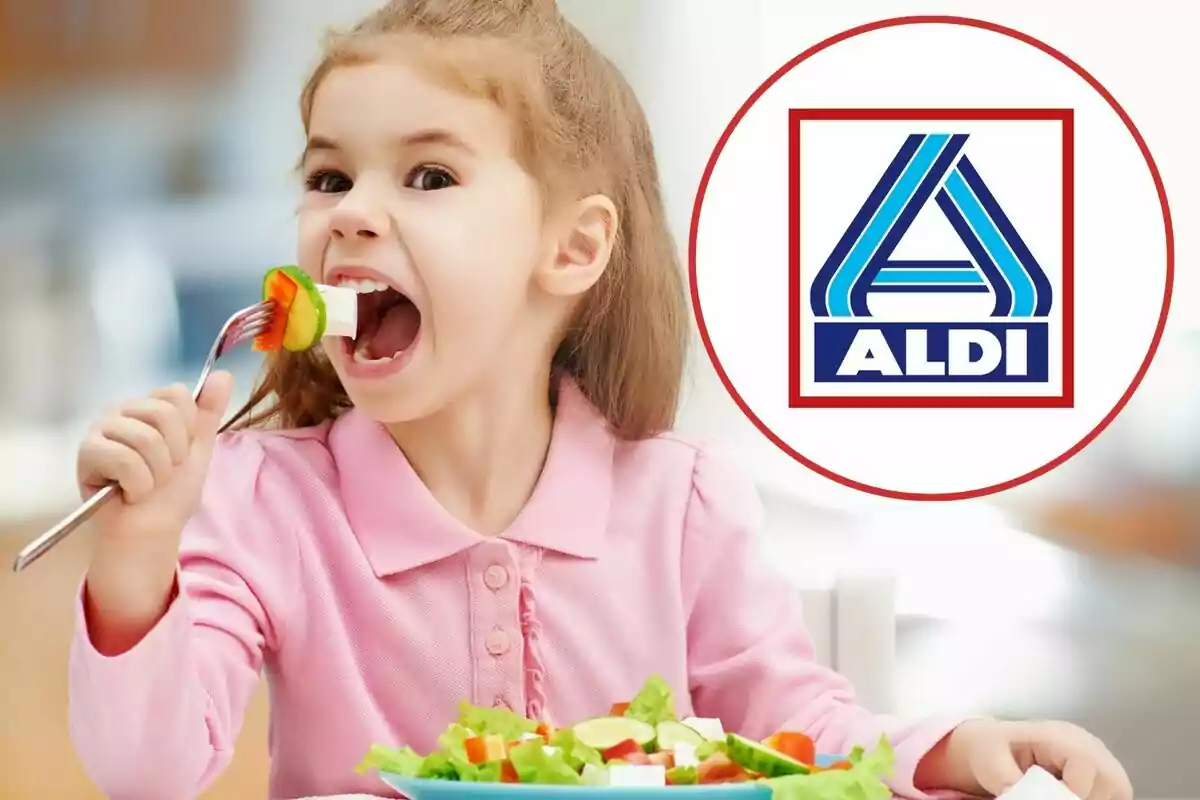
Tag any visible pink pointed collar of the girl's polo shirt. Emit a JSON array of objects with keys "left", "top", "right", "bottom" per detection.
[{"left": 329, "top": 379, "right": 614, "bottom": 578}]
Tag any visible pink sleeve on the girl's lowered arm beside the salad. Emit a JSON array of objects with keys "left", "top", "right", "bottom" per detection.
[{"left": 683, "top": 452, "right": 962, "bottom": 799}]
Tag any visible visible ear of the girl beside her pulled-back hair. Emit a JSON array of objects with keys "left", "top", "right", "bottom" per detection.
[{"left": 536, "top": 194, "right": 618, "bottom": 297}]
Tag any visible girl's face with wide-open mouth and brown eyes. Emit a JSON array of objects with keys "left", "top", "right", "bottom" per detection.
[{"left": 299, "top": 61, "right": 556, "bottom": 422}]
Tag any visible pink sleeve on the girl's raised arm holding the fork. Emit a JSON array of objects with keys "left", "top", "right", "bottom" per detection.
[{"left": 68, "top": 434, "right": 298, "bottom": 800}]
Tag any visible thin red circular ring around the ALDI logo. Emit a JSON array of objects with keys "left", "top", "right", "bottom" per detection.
[{"left": 688, "top": 14, "right": 1175, "bottom": 500}]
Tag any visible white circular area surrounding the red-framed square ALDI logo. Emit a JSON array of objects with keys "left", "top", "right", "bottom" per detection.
[{"left": 694, "top": 18, "right": 1168, "bottom": 494}]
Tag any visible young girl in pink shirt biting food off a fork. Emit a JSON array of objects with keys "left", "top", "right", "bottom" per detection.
[{"left": 70, "top": 0, "right": 1130, "bottom": 800}]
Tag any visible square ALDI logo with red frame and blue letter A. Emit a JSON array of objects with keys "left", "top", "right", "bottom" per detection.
[{"left": 790, "top": 109, "right": 1074, "bottom": 408}]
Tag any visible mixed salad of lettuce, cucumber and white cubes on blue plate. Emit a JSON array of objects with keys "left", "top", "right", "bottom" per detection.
[{"left": 358, "top": 676, "right": 893, "bottom": 800}]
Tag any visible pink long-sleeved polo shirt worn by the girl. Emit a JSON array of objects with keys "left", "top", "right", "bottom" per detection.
[{"left": 70, "top": 384, "right": 959, "bottom": 800}]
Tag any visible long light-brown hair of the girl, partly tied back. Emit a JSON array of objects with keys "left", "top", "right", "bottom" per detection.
[{"left": 230, "top": 0, "right": 689, "bottom": 439}]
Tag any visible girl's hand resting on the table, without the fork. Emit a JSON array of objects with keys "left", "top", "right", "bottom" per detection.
[{"left": 914, "top": 720, "right": 1133, "bottom": 800}]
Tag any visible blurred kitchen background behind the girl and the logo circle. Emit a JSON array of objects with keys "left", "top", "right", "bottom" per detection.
[{"left": 0, "top": 0, "right": 1200, "bottom": 799}]
